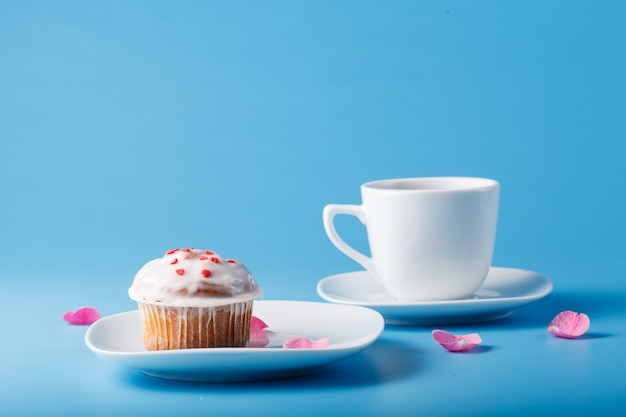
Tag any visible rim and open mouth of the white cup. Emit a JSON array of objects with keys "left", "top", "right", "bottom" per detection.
[{"left": 362, "top": 176, "right": 500, "bottom": 193}]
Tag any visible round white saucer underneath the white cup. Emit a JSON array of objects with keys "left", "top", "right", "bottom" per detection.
[{"left": 317, "top": 267, "right": 552, "bottom": 325}]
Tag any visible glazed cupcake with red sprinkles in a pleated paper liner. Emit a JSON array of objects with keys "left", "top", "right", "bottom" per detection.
[{"left": 128, "top": 248, "right": 263, "bottom": 350}]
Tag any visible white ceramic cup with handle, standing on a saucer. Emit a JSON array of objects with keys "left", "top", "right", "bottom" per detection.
[{"left": 323, "top": 177, "right": 500, "bottom": 302}]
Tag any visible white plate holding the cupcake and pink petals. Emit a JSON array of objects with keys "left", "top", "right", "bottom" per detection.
[{"left": 85, "top": 301, "right": 385, "bottom": 382}]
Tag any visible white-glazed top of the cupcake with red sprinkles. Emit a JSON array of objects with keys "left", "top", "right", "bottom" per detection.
[{"left": 128, "top": 248, "right": 263, "bottom": 306}]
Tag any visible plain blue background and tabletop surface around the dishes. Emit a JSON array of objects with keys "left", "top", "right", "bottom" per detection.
[{"left": 0, "top": 0, "right": 626, "bottom": 416}]
